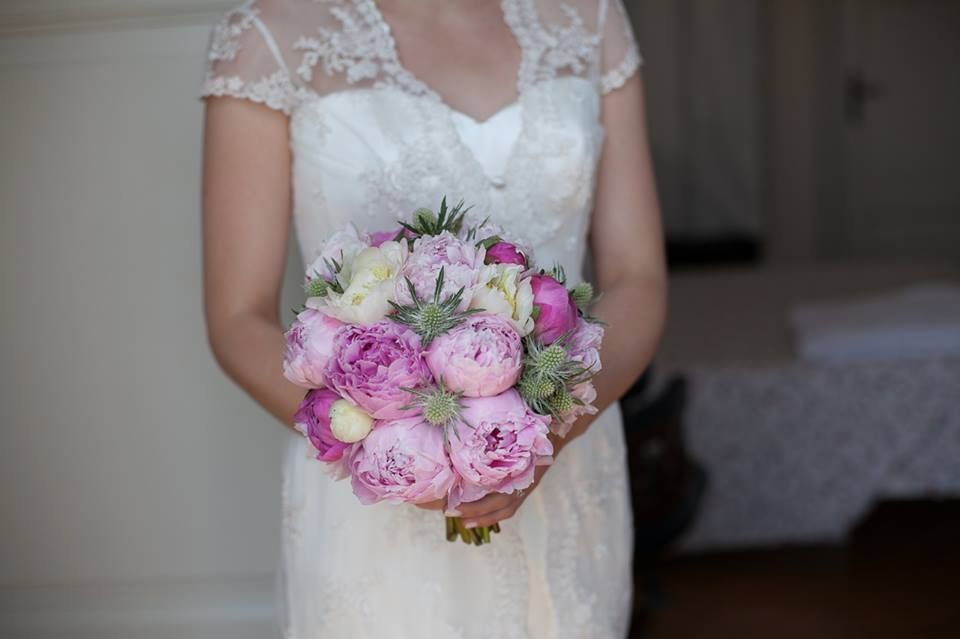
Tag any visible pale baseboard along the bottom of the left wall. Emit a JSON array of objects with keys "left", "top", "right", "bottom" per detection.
[{"left": 0, "top": 575, "right": 279, "bottom": 639}]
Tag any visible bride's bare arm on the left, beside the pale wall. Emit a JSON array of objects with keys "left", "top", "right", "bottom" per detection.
[{"left": 203, "top": 98, "right": 305, "bottom": 425}]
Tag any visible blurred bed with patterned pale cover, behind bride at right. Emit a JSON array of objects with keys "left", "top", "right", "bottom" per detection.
[{"left": 655, "top": 262, "right": 960, "bottom": 551}]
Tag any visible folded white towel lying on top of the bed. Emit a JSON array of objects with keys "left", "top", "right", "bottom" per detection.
[{"left": 790, "top": 283, "right": 960, "bottom": 364}]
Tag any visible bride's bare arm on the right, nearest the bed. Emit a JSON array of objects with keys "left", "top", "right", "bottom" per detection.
[{"left": 561, "top": 72, "right": 667, "bottom": 446}]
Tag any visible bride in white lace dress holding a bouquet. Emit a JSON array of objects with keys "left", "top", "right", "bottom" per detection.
[{"left": 202, "top": 0, "right": 665, "bottom": 639}]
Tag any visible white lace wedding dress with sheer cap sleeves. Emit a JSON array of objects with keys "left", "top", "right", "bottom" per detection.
[{"left": 202, "top": 0, "right": 640, "bottom": 639}]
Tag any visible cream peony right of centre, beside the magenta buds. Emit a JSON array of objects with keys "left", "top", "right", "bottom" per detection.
[{"left": 470, "top": 264, "right": 533, "bottom": 337}]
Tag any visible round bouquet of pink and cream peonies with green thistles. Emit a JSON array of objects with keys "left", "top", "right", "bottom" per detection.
[{"left": 283, "top": 200, "right": 603, "bottom": 545}]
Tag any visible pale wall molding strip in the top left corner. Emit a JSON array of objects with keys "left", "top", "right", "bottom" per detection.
[{"left": 0, "top": 0, "right": 238, "bottom": 37}]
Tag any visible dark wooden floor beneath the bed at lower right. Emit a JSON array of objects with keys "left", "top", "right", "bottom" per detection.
[{"left": 633, "top": 502, "right": 960, "bottom": 639}]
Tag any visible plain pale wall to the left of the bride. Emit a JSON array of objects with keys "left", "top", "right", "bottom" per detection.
[{"left": 0, "top": 0, "right": 300, "bottom": 639}]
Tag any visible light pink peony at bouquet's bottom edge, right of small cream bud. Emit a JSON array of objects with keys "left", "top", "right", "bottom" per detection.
[{"left": 348, "top": 416, "right": 456, "bottom": 504}]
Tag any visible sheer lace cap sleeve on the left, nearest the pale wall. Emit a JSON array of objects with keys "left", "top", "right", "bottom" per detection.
[{"left": 199, "top": 0, "right": 297, "bottom": 115}]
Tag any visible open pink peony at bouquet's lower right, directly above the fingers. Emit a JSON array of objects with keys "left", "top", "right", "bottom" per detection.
[{"left": 447, "top": 389, "right": 553, "bottom": 508}]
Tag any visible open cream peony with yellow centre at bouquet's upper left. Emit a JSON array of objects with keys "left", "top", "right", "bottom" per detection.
[{"left": 307, "top": 242, "right": 407, "bottom": 324}]
